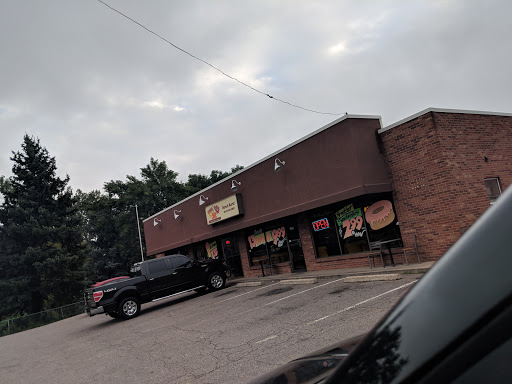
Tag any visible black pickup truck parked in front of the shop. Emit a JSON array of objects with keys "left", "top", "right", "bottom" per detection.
[{"left": 84, "top": 255, "right": 229, "bottom": 319}]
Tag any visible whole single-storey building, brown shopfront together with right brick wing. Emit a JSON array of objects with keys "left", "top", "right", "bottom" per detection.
[{"left": 144, "top": 108, "right": 512, "bottom": 276}]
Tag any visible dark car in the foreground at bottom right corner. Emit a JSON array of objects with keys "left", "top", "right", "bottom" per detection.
[{"left": 253, "top": 184, "right": 512, "bottom": 384}]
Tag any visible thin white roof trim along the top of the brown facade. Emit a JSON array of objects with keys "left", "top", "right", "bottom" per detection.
[{"left": 142, "top": 114, "right": 382, "bottom": 223}]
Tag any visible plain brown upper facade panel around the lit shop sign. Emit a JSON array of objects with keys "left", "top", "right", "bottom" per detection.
[{"left": 144, "top": 117, "right": 391, "bottom": 255}]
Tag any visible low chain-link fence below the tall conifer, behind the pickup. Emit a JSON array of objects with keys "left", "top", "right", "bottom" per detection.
[{"left": 0, "top": 302, "right": 84, "bottom": 336}]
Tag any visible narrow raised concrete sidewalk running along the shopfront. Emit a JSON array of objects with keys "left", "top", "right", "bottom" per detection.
[{"left": 227, "top": 261, "right": 435, "bottom": 285}]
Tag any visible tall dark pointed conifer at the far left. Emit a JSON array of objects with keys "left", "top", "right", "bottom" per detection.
[{"left": 0, "top": 135, "right": 83, "bottom": 316}]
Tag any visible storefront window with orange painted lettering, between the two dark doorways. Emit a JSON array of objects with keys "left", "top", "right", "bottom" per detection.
[{"left": 247, "top": 223, "right": 290, "bottom": 266}]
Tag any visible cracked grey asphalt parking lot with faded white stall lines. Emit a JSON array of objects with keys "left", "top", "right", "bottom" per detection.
[{"left": 0, "top": 275, "right": 420, "bottom": 384}]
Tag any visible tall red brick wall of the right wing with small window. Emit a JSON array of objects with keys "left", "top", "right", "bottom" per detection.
[{"left": 380, "top": 112, "right": 512, "bottom": 260}]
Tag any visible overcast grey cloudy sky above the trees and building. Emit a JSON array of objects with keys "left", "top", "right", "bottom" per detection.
[{"left": 0, "top": 0, "right": 512, "bottom": 191}]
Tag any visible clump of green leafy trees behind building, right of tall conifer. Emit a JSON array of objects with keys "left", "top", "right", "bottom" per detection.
[{"left": 77, "top": 158, "right": 242, "bottom": 282}]
